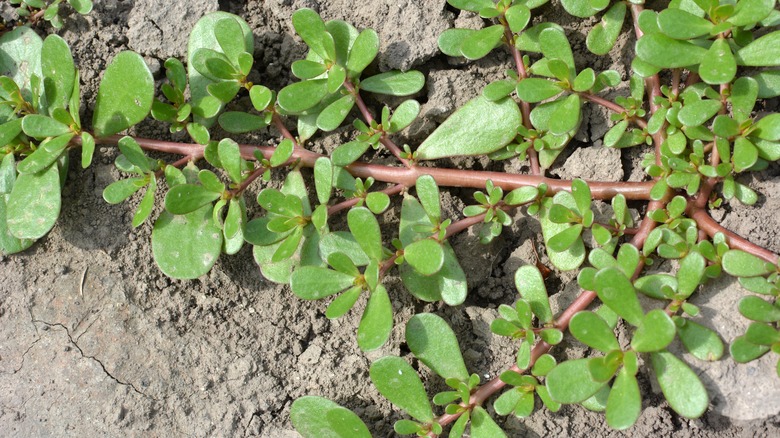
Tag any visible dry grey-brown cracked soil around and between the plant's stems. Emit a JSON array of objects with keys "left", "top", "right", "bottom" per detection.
[{"left": 0, "top": 0, "right": 780, "bottom": 437}]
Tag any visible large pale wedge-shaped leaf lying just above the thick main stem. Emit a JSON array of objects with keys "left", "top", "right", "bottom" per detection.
[{"left": 417, "top": 97, "right": 522, "bottom": 160}]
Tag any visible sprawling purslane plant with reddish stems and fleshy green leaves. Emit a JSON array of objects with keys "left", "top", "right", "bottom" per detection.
[{"left": 0, "top": 0, "right": 780, "bottom": 437}]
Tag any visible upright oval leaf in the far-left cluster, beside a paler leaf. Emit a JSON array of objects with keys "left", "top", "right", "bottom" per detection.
[{"left": 41, "top": 34, "right": 76, "bottom": 114}]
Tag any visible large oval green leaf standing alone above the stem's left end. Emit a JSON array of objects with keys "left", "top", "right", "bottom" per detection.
[{"left": 92, "top": 52, "right": 154, "bottom": 137}]
